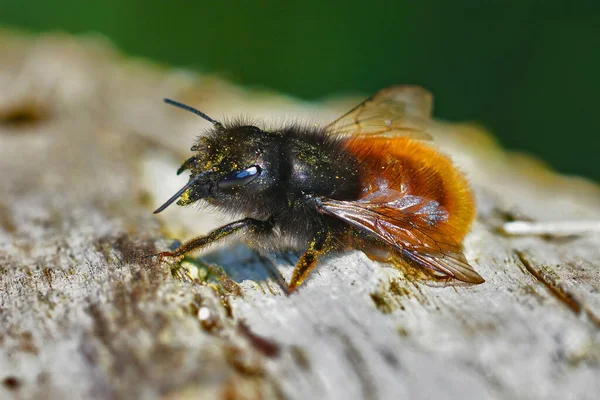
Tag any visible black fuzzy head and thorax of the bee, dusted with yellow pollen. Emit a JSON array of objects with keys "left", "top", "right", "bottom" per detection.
[{"left": 192, "top": 122, "right": 360, "bottom": 248}]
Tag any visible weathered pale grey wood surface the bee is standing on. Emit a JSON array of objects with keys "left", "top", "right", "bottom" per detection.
[{"left": 0, "top": 33, "right": 600, "bottom": 399}]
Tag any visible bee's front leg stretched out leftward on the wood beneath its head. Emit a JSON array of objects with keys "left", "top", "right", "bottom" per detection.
[{"left": 155, "top": 218, "right": 273, "bottom": 260}]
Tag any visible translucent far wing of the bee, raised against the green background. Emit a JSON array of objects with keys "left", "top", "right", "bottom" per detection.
[{"left": 327, "top": 86, "right": 433, "bottom": 140}]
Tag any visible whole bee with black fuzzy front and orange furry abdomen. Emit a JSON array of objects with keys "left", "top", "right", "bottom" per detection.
[{"left": 154, "top": 86, "right": 484, "bottom": 293}]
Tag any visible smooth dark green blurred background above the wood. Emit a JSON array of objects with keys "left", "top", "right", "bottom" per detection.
[{"left": 0, "top": 0, "right": 600, "bottom": 181}]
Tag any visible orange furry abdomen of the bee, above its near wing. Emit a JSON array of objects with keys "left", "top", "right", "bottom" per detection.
[{"left": 346, "top": 137, "right": 475, "bottom": 243}]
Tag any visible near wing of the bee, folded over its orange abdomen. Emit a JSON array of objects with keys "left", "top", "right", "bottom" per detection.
[{"left": 319, "top": 189, "right": 484, "bottom": 283}]
